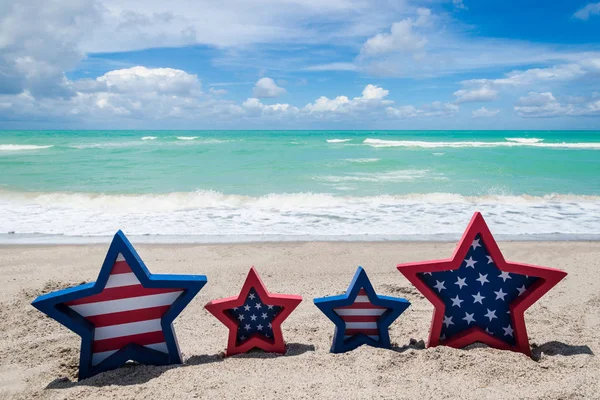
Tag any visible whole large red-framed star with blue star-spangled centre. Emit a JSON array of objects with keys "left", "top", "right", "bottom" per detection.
[{"left": 398, "top": 212, "right": 567, "bottom": 356}]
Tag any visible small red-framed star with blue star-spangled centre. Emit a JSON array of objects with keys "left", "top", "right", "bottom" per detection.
[{"left": 205, "top": 267, "right": 302, "bottom": 356}]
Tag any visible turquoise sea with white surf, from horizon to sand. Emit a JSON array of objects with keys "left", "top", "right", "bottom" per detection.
[{"left": 0, "top": 131, "right": 600, "bottom": 242}]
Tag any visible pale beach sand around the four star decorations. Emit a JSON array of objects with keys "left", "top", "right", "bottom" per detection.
[{"left": 0, "top": 242, "right": 600, "bottom": 399}]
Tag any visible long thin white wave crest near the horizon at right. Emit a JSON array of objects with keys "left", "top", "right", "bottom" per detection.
[{"left": 363, "top": 138, "right": 600, "bottom": 150}]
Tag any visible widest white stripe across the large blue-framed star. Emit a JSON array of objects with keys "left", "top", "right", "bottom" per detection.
[{"left": 69, "top": 291, "right": 183, "bottom": 317}]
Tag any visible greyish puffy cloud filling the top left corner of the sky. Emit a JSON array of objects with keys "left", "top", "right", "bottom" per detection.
[{"left": 0, "top": 0, "right": 100, "bottom": 97}]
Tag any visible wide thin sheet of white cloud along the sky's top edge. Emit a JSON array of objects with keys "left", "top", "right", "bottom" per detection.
[{"left": 84, "top": 0, "right": 408, "bottom": 52}]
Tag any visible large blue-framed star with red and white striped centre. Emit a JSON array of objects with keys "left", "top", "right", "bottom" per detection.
[{"left": 32, "top": 231, "right": 206, "bottom": 380}]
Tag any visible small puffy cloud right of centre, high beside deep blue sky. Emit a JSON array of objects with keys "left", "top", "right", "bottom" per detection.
[{"left": 360, "top": 8, "right": 431, "bottom": 56}]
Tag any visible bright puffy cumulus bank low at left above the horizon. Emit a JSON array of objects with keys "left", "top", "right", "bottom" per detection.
[{"left": 0, "top": 66, "right": 244, "bottom": 123}]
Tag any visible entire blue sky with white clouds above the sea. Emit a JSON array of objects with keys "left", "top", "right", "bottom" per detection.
[{"left": 0, "top": 0, "right": 600, "bottom": 129}]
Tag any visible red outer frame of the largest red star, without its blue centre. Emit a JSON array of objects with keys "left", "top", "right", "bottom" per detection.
[{"left": 398, "top": 212, "right": 567, "bottom": 356}]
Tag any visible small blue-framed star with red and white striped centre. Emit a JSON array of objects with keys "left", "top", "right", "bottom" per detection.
[{"left": 314, "top": 267, "right": 410, "bottom": 353}]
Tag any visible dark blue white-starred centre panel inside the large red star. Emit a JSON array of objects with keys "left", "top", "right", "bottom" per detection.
[{"left": 418, "top": 235, "right": 538, "bottom": 346}]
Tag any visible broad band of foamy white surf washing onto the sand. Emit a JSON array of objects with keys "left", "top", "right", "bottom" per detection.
[{"left": 0, "top": 191, "right": 600, "bottom": 241}]
